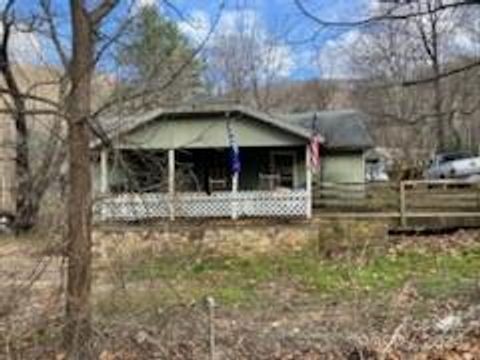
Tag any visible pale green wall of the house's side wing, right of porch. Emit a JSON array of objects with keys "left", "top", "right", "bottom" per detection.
[{"left": 321, "top": 152, "right": 365, "bottom": 183}]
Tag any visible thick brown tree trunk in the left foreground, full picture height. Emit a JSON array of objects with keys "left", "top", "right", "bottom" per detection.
[{"left": 64, "top": 0, "right": 93, "bottom": 360}]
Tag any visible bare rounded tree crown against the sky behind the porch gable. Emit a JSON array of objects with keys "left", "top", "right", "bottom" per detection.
[{"left": 207, "top": 9, "right": 292, "bottom": 110}]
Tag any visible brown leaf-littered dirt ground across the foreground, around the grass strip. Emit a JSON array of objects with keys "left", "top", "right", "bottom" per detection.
[{"left": 0, "top": 231, "right": 480, "bottom": 360}]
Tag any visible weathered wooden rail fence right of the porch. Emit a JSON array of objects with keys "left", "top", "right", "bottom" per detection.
[{"left": 313, "top": 180, "right": 480, "bottom": 225}]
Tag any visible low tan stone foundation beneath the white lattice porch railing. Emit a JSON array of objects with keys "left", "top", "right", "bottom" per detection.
[{"left": 94, "top": 220, "right": 388, "bottom": 259}]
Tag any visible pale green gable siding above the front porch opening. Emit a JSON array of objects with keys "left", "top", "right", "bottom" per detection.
[{"left": 118, "top": 118, "right": 308, "bottom": 149}]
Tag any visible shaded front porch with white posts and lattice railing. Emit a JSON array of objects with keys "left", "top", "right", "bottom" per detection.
[{"left": 94, "top": 145, "right": 312, "bottom": 221}]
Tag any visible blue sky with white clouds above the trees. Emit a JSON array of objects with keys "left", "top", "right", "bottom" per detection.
[{"left": 6, "top": 0, "right": 476, "bottom": 79}]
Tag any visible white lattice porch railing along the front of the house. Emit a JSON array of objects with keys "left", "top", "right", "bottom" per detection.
[{"left": 94, "top": 190, "right": 311, "bottom": 221}]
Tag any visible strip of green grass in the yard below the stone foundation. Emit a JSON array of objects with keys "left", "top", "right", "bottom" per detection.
[{"left": 94, "top": 246, "right": 480, "bottom": 320}]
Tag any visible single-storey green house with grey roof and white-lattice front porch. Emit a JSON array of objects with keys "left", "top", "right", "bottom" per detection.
[{"left": 93, "top": 104, "right": 371, "bottom": 220}]
